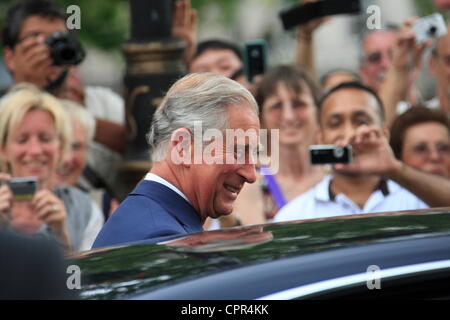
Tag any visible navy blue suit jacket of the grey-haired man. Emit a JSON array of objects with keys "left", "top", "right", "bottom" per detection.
[{"left": 92, "top": 180, "right": 203, "bottom": 249}]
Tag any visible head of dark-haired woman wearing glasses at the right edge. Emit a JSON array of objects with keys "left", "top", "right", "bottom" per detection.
[{"left": 390, "top": 107, "right": 450, "bottom": 178}]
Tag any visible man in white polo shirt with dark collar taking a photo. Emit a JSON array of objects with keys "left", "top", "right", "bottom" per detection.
[{"left": 275, "top": 82, "right": 450, "bottom": 221}]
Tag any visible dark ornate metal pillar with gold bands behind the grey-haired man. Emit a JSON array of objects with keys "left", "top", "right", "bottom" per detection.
[{"left": 119, "top": 0, "right": 186, "bottom": 198}]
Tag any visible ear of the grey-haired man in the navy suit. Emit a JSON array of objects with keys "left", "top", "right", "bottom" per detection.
[{"left": 167, "top": 128, "right": 194, "bottom": 167}]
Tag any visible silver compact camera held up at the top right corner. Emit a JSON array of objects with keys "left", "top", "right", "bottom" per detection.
[{"left": 412, "top": 13, "right": 447, "bottom": 43}]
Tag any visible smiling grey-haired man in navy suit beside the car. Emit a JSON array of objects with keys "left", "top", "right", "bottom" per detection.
[{"left": 93, "top": 73, "right": 259, "bottom": 248}]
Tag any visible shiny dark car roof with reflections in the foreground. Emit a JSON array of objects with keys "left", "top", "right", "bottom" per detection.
[{"left": 70, "top": 208, "right": 450, "bottom": 299}]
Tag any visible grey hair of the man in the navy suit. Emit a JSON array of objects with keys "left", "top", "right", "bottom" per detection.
[{"left": 147, "top": 73, "right": 258, "bottom": 162}]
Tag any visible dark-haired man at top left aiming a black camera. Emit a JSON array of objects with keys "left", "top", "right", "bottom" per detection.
[{"left": 3, "top": 0, "right": 125, "bottom": 198}]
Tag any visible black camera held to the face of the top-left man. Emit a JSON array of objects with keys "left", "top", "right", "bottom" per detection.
[{"left": 45, "top": 32, "right": 86, "bottom": 66}]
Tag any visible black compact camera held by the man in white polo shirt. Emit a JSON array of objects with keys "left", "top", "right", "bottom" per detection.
[{"left": 309, "top": 144, "right": 353, "bottom": 165}]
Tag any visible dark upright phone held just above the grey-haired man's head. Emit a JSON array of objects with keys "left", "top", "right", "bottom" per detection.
[{"left": 244, "top": 39, "right": 267, "bottom": 83}]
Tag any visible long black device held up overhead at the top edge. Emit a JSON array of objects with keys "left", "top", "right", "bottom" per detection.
[{"left": 279, "top": 0, "right": 361, "bottom": 30}]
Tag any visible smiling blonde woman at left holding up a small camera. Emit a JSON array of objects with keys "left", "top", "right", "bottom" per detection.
[{"left": 0, "top": 84, "right": 97, "bottom": 253}]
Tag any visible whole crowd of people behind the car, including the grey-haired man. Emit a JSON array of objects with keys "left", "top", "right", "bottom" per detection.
[{"left": 0, "top": 0, "right": 450, "bottom": 253}]
